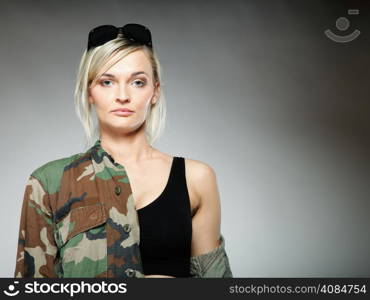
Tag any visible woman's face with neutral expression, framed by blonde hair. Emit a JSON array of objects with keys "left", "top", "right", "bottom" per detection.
[{"left": 89, "top": 50, "right": 160, "bottom": 133}]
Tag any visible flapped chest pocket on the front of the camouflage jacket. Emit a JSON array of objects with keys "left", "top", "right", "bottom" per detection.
[{"left": 54, "top": 203, "right": 107, "bottom": 277}]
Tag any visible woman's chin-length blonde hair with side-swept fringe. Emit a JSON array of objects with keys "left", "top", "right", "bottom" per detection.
[{"left": 74, "top": 37, "right": 166, "bottom": 148}]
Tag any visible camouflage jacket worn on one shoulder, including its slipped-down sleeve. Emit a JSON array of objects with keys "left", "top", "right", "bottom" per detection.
[{"left": 14, "top": 140, "right": 232, "bottom": 278}]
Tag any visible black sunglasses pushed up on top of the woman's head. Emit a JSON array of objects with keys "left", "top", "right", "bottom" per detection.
[{"left": 87, "top": 23, "right": 153, "bottom": 51}]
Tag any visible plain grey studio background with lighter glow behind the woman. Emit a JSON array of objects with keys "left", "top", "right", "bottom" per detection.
[{"left": 0, "top": 0, "right": 370, "bottom": 277}]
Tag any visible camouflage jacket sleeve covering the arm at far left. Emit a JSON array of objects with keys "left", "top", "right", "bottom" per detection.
[{"left": 14, "top": 175, "right": 58, "bottom": 277}]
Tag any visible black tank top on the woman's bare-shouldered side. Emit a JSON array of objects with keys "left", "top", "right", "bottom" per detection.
[{"left": 137, "top": 156, "right": 192, "bottom": 277}]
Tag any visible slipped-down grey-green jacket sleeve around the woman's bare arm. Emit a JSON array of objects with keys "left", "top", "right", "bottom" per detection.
[{"left": 190, "top": 234, "right": 233, "bottom": 278}]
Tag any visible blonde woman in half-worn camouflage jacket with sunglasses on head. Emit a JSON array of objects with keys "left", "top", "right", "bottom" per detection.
[{"left": 14, "top": 24, "right": 232, "bottom": 278}]
